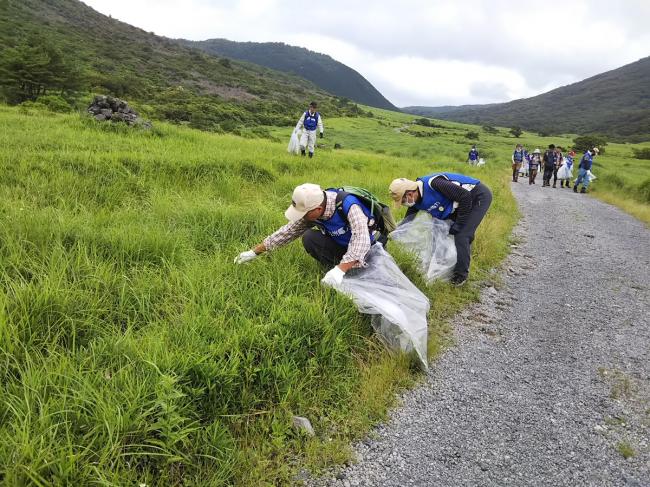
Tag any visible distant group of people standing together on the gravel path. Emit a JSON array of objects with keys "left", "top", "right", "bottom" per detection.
[{"left": 511, "top": 144, "right": 599, "bottom": 193}]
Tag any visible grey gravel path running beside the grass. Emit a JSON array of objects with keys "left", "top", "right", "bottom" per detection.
[{"left": 309, "top": 181, "right": 650, "bottom": 487}]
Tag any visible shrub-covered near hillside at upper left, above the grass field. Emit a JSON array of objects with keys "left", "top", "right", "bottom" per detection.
[{"left": 0, "top": 0, "right": 370, "bottom": 131}]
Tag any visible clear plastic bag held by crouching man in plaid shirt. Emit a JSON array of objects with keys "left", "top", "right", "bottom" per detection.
[{"left": 326, "top": 243, "right": 429, "bottom": 370}]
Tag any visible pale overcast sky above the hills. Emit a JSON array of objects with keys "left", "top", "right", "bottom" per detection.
[{"left": 84, "top": 0, "right": 650, "bottom": 106}]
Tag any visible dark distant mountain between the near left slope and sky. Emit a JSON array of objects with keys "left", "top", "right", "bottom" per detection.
[{"left": 181, "top": 39, "right": 397, "bottom": 110}]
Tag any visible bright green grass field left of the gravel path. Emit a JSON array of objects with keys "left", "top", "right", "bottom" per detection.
[{"left": 0, "top": 102, "right": 644, "bottom": 486}]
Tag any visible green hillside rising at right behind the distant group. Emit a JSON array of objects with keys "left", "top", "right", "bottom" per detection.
[{"left": 403, "top": 57, "right": 650, "bottom": 140}]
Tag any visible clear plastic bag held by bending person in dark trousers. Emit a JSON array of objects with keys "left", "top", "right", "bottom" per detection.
[{"left": 390, "top": 211, "right": 456, "bottom": 283}]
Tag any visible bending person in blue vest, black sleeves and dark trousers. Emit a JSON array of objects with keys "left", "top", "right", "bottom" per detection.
[{"left": 388, "top": 172, "right": 492, "bottom": 286}]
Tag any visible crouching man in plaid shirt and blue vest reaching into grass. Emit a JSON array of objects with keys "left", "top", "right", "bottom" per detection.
[{"left": 235, "top": 183, "right": 375, "bottom": 285}]
